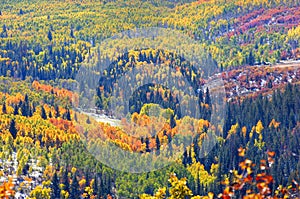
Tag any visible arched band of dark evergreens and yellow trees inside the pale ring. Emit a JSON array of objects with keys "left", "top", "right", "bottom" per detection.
[{"left": 96, "top": 49, "right": 216, "bottom": 118}]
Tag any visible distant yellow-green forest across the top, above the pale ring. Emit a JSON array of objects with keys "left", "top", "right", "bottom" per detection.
[{"left": 0, "top": 0, "right": 300, "bottom": 83}]
